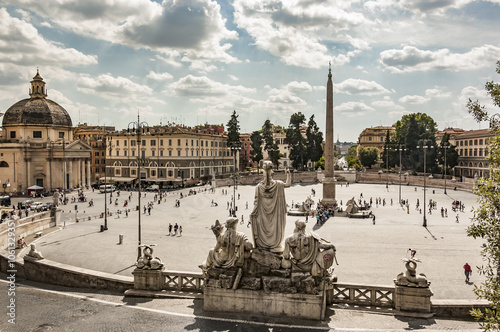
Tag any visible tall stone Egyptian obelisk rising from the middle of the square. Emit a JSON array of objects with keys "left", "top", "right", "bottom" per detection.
[{"left": 322, "top": 64, "right": 337, "bottom": 205}]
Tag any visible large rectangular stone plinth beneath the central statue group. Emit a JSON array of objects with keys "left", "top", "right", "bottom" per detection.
[{"left": 203, "top": 287, "right": 326, "bottom": 320}]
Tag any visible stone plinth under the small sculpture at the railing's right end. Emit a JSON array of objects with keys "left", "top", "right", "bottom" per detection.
[{"left": 394, "top": 285, "right": 434, "bottom": 313}]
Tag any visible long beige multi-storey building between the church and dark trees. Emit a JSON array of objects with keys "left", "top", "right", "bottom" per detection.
[{"left": 106, "top": 125, "right": 234, "bottom": 185}]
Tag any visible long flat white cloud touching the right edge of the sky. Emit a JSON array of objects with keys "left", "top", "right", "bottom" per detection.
[{"left": 380, "top": 45, "right": 500, "bottom": 73}]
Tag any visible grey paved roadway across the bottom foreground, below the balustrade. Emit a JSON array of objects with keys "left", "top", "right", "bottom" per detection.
[{"left": 0, "top": 275, "right": 479, "bottom": 332}]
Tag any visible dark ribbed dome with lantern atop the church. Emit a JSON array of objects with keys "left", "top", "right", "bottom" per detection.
[{"left": 2, "top": 70, "right": 73, "bottom": 127}]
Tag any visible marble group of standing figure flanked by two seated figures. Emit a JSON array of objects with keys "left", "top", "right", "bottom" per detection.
[{"left": 200, "top": 161, "right": 336, "bottom": 293}]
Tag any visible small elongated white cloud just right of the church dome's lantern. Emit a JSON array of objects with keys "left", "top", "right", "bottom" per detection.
[{"left": 77, "top": 74, "right": 153, "bottom": 101}]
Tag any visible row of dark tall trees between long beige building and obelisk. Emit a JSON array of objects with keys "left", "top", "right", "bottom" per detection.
[{"left": 227, "top": 111, "right": 323, "bottom": 170}]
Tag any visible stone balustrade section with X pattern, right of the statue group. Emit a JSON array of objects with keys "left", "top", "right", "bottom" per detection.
[{"left": 332, "top": 283, "right": 395, "bottom": 307}]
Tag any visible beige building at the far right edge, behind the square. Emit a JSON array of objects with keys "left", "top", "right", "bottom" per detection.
[{"left": 454, "top": 129, "right": 494, "bottom": 178}]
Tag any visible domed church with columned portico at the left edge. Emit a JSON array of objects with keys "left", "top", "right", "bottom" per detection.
[{"left": 0, "top": 70, "right": 91, "bottom": 194}]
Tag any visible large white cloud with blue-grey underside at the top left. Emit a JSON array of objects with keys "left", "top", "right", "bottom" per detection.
[{"left": 10, "top": 0, "right": 238, "bottom": 67}]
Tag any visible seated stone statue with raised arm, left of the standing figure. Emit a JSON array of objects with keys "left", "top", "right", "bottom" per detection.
[{"left": 200, "top": 217, "right": 253, "bottom": 270}]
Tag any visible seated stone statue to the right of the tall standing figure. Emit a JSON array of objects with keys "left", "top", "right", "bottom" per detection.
[{"left": 281, "top": 220, "right": 336, "bottom": 277}]
